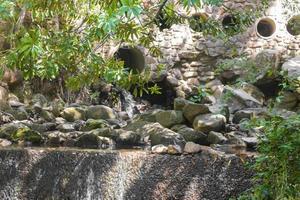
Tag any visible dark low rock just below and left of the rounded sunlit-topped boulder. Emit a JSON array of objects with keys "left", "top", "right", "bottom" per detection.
[{"left": 171, "top": 125, "right": 208, "bottom": 145}]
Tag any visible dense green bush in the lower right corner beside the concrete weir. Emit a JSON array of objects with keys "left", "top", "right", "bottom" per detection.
[{"left": 239, "top": 115, "right": 300, "bottom": 200}]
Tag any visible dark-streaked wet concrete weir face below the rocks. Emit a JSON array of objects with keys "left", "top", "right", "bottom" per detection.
[{"left": 0, "top": 149, "right": 251, "bottom": 200}]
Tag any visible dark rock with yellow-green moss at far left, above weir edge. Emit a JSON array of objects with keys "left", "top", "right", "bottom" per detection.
[{"left": 11, "top": 128, "right": 43, "bottom": 145}]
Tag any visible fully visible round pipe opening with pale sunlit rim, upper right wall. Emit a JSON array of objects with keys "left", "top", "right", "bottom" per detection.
[{"left": 256, "top": 17, "right": 276, "bottom": 38}]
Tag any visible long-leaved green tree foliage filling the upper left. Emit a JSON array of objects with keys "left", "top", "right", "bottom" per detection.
[{"left": 0, "top": 0, "right": 227, "bottom": 92}]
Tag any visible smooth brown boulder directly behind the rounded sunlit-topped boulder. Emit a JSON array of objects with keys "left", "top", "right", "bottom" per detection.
[{"left": 183, "top": 102, "right": 210, "bottom": 123}]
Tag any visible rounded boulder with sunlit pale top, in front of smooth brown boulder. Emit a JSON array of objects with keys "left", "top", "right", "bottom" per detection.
[{"left": 193, "top": 114, "right": 226, "bottom": 133}]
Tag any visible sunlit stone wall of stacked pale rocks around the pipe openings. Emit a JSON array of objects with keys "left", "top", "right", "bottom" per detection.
[{"left": 105, "top": 0, "right": 300, "bottom": 97}]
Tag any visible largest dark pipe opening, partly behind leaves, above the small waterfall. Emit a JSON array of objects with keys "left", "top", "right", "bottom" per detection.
[{"left": 114, "top": 46, "right": 146, "bottom": 73}]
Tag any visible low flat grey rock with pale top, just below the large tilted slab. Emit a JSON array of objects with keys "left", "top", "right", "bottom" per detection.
[{"left": 232, "top": 108, "right": 268, "bottom": 124}]
